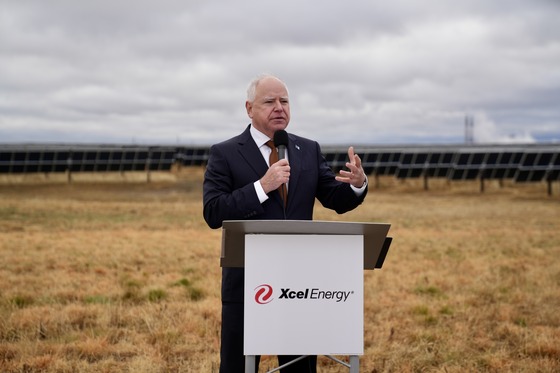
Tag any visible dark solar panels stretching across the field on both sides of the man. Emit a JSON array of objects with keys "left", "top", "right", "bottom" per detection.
[{"left": 0, "top": 144, "right": 560, "bottom": 189}]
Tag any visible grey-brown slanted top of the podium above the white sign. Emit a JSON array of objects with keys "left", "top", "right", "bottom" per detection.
[{"left": 220, "top": 220, "right": 391, "bottom": 269}]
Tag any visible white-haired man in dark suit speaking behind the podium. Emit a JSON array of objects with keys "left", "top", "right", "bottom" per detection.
[{"left": 203, "top": 75, "right": 367, "bottom": 373}]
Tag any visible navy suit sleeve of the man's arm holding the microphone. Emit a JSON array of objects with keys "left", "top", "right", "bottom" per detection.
[{"left": 203, "top": 145, "right": 263, "bottom": 229}]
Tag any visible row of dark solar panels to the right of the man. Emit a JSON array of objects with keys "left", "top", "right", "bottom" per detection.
[{"left": 325, "top": 146, "right": 560, "bottom": 182}]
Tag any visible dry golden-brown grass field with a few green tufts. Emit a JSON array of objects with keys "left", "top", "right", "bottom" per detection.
[{"left": 0, "top": 169, "right": 560, "bottom": 373}]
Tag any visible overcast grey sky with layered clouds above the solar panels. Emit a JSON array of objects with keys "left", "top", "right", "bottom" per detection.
[{"left": 0, "top": 0, "right": 560, "bottom": 145}]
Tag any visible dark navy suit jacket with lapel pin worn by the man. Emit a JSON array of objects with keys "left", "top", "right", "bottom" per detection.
[{"left": 203, "top": 127, "right": 367, "bottom": 302}]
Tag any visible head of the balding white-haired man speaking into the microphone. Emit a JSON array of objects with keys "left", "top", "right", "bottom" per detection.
[{"left": 245, "top": 77, "right": 290, "bottom": 138}]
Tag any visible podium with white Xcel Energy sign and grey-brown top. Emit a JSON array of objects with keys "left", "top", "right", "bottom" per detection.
[{"left": 221, "top": 220, "right": 391, "bottom": 373}]
